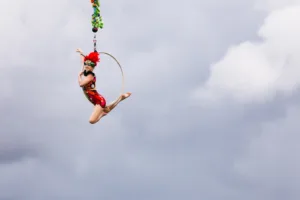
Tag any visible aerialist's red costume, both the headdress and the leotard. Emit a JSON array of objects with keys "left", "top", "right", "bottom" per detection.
[{"left": 83, "top": 52, "right": 106, "bottom": 108}]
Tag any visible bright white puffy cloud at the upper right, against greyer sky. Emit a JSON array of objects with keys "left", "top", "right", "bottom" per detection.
[{"left": 193, "top": 3, "right": 300, "bottom": 103}]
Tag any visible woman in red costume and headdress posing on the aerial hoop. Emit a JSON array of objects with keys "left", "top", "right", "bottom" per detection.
[{"left": 77, "top": 49, "right": 131, "bottom": 124}]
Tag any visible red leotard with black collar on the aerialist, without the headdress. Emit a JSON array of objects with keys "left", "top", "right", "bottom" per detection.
[{"left": 83, "top": 71, "right": 106, "bottom": 108}]
